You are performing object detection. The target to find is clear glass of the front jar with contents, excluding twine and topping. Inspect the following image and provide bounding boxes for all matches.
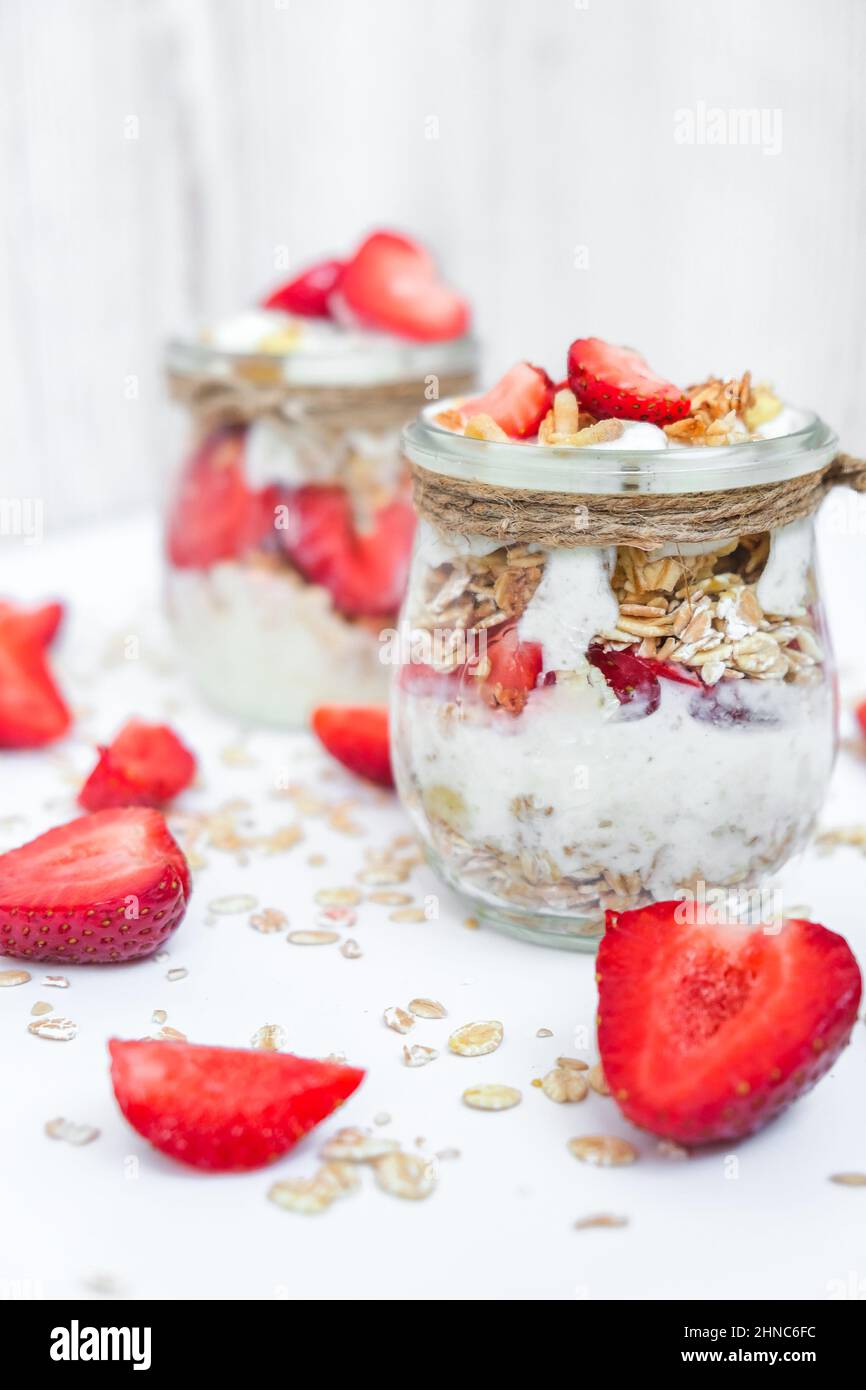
[392,411,837,949]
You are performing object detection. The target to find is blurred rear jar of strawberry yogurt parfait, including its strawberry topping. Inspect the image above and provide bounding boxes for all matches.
[165,232,475,726]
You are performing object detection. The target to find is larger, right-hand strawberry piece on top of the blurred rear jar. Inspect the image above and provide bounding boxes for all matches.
[331,232,468,342]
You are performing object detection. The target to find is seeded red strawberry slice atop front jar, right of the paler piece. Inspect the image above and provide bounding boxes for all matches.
[569,338,689,425]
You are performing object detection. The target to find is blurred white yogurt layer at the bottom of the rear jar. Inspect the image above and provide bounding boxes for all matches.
[168,562,388,727]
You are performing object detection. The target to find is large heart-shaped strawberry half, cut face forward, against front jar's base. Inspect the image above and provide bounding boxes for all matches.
[598,902,862,1144]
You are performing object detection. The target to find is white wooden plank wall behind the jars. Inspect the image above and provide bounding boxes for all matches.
[0,0,866,534]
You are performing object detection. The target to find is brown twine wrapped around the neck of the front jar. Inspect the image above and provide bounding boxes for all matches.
[411,453,866,550]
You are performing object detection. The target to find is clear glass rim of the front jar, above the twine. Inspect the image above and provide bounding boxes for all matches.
[403,400,838,496]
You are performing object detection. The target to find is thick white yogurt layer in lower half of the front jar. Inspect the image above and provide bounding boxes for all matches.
[395,678,834,910]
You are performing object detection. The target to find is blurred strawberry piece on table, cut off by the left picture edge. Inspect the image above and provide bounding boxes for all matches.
[0,602,72,748]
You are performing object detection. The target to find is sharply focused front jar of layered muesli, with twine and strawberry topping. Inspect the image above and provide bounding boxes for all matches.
[392,339,866,948]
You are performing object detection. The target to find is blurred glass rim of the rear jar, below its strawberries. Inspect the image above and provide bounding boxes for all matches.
[165,331,478,386]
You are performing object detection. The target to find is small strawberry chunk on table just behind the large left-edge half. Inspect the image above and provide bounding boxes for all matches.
[78,719,196,810]
